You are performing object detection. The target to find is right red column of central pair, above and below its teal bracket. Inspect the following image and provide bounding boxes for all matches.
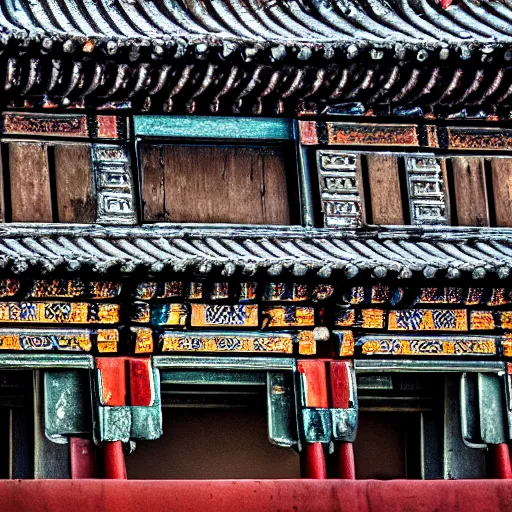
[329,361,356,480]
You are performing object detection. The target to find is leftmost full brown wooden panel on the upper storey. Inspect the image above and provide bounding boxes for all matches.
[9,142,52,222]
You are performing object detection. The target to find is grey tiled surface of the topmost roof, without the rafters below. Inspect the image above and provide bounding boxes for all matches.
[0,0,512,54]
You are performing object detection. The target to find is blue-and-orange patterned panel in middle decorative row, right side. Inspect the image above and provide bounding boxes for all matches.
[388,309,468,331]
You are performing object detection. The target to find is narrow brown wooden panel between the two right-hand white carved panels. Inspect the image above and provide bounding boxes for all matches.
[366,155,404,224]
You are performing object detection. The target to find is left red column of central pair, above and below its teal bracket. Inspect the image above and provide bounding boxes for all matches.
[298,360,329,480]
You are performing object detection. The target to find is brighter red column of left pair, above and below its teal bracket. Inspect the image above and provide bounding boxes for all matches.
[96,357,127,480]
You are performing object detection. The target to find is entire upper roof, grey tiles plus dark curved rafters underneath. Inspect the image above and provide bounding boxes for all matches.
[0,0,512,114]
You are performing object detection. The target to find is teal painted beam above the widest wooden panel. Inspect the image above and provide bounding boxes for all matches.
[133,116,293,140]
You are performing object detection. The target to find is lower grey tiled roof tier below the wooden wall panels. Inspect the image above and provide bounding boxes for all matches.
[0,224,512,279]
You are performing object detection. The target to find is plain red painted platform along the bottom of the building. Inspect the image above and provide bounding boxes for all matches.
[0,480,512,512]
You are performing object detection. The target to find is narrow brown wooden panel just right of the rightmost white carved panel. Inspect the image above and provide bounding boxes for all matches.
[452,157,489,226]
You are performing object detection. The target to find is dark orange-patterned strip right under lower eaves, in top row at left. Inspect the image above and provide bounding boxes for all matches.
[29,279,121,299]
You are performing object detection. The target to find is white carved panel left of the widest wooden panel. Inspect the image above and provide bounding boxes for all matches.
[91,144,137,225]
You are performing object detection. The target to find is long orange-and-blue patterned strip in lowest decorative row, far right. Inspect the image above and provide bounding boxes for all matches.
[356,336,497,356]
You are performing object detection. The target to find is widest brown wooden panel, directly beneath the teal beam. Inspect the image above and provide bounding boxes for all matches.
[141,145,290,224]
